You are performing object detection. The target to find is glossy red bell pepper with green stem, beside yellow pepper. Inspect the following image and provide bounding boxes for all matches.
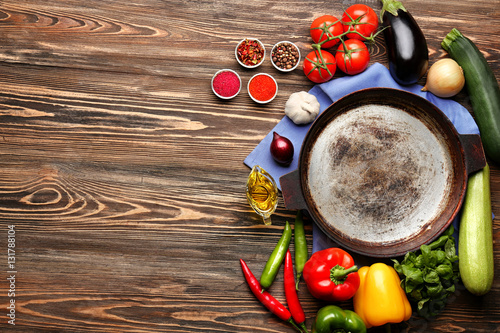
[302,248,360,302]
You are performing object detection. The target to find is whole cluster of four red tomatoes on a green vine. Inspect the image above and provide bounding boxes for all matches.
[303,4,378,83]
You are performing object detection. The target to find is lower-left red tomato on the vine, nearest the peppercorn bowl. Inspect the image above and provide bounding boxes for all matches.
[303,50,337,83]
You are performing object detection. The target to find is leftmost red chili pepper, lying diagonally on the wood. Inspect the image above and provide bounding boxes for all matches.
[240,259,301,332]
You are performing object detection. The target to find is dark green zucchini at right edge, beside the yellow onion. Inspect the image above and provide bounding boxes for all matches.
[441,29,500,164]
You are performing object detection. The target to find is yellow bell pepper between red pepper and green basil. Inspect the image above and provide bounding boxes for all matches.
[353,263,412,328]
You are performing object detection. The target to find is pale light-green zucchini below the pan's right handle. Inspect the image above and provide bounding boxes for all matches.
[458,164,494,296]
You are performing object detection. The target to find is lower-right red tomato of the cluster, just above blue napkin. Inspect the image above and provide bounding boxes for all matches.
[335,39,370,75]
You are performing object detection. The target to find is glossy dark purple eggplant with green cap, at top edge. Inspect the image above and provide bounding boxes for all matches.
[380,0,429,85]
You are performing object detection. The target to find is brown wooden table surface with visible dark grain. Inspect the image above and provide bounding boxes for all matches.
[0,0,500,332]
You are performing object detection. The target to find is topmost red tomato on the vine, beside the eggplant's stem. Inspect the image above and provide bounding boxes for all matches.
[342,4,378,40]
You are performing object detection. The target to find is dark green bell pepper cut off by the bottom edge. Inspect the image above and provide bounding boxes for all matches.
[312,305,366,333]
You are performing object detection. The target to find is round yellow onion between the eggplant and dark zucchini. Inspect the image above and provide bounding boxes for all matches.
[422,58,465,97]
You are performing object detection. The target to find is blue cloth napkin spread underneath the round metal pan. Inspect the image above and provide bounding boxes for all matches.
[244,63,479,253]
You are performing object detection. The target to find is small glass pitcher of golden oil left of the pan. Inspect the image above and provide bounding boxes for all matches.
[247,165,278,225]
